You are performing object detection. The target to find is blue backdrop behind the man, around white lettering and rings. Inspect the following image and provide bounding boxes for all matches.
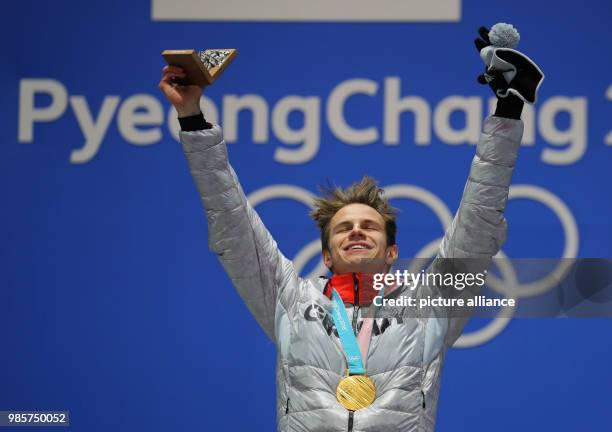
[0,0,612,431]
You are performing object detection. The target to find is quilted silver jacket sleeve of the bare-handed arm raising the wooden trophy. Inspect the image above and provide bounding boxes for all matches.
[180,125,298,340]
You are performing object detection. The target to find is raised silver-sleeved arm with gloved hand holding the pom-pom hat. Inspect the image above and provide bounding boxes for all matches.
[432,24,544,346]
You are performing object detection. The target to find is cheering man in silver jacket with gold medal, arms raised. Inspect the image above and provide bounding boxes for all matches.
[160,29,537,432]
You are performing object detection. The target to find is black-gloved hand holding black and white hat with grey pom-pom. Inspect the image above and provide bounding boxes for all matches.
[474,23,544,104]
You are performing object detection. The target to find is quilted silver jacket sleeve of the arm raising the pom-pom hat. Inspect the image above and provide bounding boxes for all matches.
[434,116,523,346]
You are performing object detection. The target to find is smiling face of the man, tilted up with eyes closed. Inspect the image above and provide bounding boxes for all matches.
[323,203,398,274]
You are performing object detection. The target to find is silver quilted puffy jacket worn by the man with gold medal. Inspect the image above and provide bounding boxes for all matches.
[180,117,523,432]
